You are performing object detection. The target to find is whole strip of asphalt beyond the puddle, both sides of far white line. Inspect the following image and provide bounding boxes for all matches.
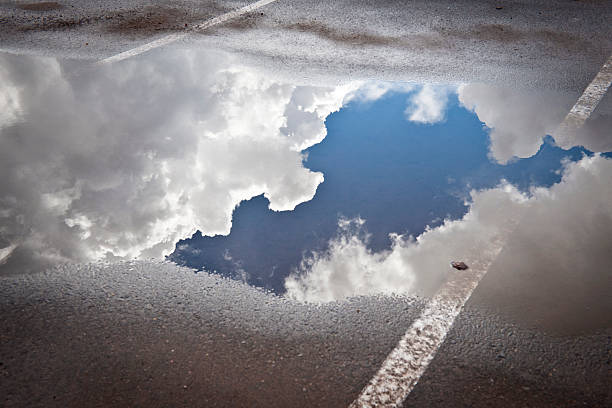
[0,0,612,91]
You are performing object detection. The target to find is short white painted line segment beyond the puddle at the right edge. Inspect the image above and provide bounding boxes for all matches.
[553,55,612,146]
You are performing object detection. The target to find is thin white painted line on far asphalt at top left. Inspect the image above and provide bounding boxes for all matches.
[96,0,277,65]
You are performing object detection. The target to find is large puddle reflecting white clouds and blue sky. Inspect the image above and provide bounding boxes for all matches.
[0,48,612,306]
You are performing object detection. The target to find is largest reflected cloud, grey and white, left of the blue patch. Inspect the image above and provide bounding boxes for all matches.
[0,51,364,272]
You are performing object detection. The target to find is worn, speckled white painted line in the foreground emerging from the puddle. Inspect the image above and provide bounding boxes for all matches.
[350,242,503,408]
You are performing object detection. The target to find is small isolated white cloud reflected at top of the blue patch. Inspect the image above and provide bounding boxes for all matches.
[404,85,448,124]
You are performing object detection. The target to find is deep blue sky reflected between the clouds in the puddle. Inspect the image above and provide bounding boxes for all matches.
[171,90,584,291]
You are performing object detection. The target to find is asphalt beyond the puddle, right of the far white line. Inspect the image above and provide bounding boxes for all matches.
[196,0,612,94]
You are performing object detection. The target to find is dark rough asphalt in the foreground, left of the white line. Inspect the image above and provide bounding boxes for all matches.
[0,262,423,407]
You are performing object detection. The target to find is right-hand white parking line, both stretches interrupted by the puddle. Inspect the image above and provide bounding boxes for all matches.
[350,51,612,408]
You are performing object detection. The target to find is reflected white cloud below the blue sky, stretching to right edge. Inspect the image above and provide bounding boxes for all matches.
[286,156,612,301]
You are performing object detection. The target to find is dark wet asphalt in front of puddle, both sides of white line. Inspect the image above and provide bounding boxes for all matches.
[0,262,612,407]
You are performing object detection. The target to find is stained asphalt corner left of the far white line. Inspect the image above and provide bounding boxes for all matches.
[0,0,248,60]
